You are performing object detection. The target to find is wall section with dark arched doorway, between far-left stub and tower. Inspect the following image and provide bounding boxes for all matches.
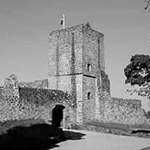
[19,88,74,126]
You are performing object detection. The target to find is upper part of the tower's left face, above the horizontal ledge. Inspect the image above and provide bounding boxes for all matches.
[49,25,83,78]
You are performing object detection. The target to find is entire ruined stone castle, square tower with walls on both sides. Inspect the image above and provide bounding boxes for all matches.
[0,23,150,128]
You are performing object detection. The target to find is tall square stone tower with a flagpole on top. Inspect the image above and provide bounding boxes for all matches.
[49,23,108,124]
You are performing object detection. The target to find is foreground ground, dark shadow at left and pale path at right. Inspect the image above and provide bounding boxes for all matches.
[0,119,150,150]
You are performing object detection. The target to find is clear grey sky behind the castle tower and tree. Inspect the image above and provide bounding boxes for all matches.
[0,0,150,98]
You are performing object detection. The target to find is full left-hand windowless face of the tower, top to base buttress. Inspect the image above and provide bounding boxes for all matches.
[49,24,84,124]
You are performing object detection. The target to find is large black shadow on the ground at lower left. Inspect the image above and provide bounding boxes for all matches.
[0,124,85,150]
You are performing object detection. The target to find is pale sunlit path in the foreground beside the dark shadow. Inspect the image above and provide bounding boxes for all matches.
[53,130,150,150]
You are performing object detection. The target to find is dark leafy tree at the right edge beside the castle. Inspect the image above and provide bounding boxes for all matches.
[124,55,150,98]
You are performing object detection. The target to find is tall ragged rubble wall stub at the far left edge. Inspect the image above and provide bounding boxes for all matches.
[0,74,19,121]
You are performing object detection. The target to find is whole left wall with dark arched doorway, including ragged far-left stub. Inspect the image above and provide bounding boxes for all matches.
[0,76,75,128]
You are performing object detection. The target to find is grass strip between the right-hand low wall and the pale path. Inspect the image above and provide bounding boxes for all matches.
[83,121,150,138]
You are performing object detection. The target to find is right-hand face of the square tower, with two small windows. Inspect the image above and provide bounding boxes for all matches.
[82,24,106,123]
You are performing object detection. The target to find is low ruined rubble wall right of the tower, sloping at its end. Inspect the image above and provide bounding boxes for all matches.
[98,94,150,125]
